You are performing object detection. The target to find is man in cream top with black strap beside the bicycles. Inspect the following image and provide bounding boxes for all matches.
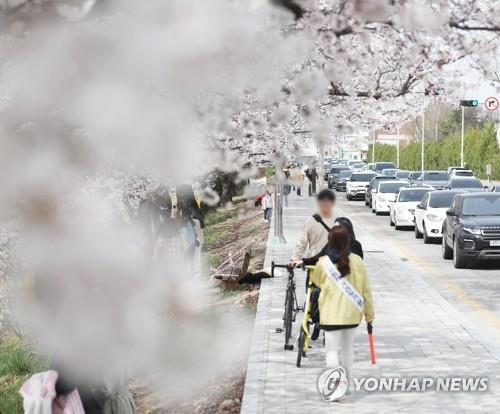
[291,189,335,265]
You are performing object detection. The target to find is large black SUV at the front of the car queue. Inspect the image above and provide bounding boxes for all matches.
[442,193,500,268]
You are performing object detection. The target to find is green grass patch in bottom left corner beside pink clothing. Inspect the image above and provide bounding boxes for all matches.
[0,338,48,414]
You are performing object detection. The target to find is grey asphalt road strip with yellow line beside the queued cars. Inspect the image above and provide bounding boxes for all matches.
[337,192,500,356]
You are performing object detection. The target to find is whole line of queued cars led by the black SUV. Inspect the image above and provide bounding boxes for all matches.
[334,163,500,268]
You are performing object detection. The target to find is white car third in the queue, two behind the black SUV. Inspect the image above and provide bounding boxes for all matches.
[389,187,433,230]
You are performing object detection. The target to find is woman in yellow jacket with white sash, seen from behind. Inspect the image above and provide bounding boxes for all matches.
[311,225,374,381]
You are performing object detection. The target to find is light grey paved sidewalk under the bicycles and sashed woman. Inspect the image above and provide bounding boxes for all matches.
[241,192,500,414]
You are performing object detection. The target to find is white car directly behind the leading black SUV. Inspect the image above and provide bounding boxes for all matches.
[415,190,463,244]
